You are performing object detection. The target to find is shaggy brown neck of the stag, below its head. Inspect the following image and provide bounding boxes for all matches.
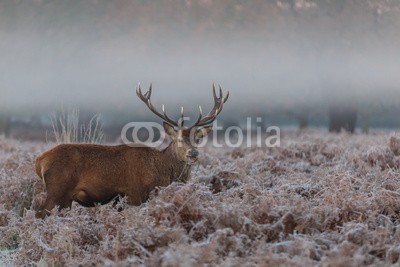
[163,142,191,182]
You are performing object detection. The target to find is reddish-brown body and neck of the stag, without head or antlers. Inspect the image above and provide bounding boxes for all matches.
[35,144,190,217]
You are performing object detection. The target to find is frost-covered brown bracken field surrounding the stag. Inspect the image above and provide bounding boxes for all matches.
[0,130,400,266]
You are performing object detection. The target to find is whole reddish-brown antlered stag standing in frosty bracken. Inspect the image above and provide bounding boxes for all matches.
[35,85,229,218]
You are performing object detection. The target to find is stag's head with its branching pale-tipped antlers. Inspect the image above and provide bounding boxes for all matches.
[136,84,229,164]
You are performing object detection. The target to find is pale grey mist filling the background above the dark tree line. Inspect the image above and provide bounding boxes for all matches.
[0,0,400,127]
